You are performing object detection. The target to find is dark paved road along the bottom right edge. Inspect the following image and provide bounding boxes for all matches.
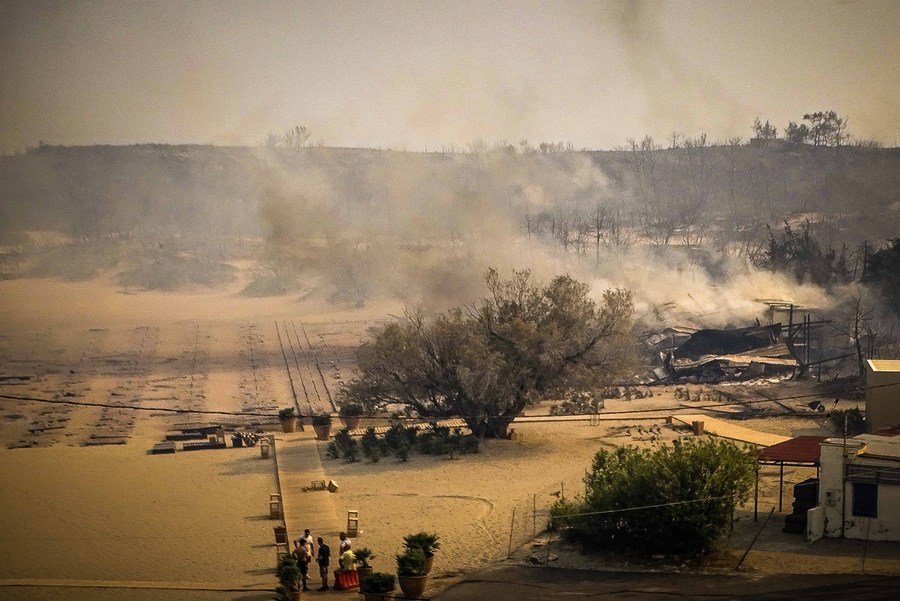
[435,566,900,601]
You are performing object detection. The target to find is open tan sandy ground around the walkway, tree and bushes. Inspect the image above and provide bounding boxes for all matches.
[0,280,900,599]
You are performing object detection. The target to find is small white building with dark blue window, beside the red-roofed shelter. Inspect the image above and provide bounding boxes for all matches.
[810,434,900,541]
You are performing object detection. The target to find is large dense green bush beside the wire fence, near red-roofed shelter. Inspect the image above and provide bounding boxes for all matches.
[551,438,756,555]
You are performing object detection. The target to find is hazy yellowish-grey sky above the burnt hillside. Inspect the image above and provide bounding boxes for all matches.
[0,0,900,152]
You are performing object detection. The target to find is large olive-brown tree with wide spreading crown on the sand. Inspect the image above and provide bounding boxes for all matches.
[341,270,633,437]
